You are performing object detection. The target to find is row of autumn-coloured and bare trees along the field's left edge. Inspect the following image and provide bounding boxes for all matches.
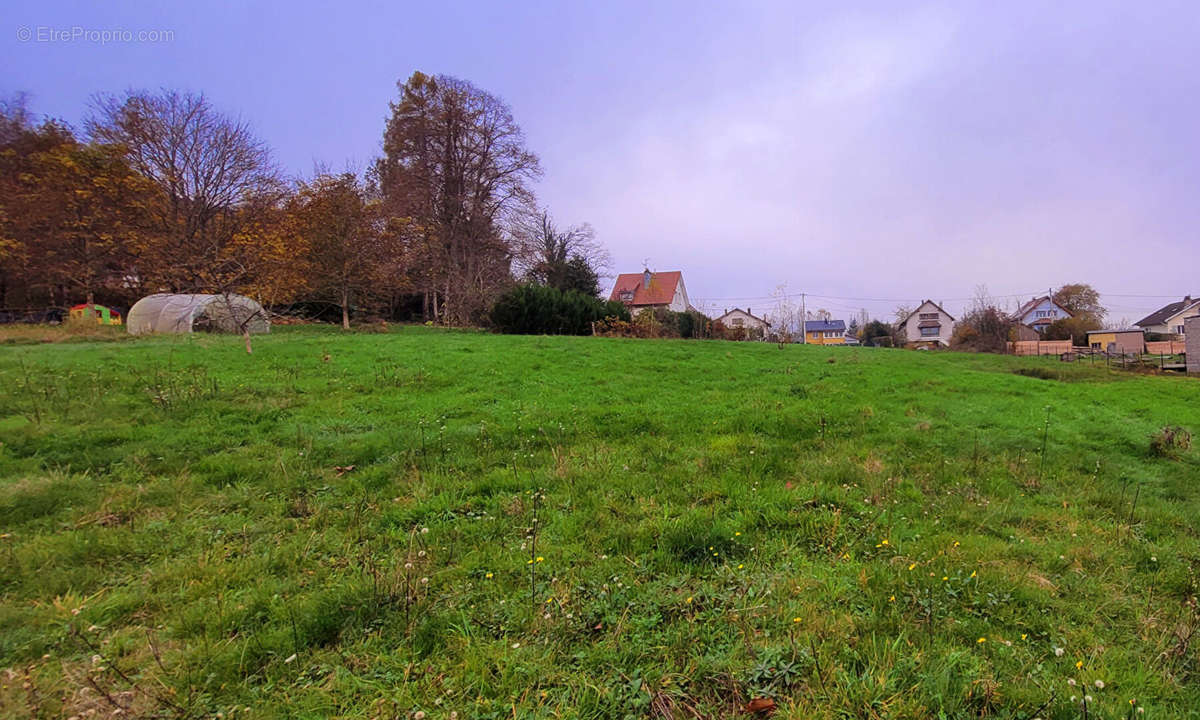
[0,72,608,326]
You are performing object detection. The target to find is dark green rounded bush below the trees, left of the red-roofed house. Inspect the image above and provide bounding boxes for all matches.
[491,284,629,335]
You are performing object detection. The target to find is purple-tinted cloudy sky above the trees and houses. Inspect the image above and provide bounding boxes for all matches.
[0,0,1200,320]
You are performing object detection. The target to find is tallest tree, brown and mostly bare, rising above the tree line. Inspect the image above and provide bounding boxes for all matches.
[374,72,541,324]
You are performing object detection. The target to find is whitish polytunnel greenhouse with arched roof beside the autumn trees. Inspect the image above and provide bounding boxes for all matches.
[125,293,271,335]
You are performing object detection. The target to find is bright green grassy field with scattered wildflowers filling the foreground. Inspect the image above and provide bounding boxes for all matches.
[0,328,1200,720]
